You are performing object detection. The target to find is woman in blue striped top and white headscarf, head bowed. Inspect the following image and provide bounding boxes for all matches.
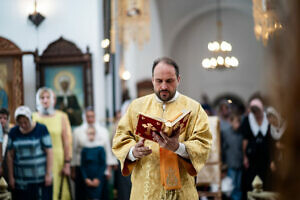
[7,106,53,200]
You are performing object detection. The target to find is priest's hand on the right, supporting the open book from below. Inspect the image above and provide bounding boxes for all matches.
[152,129,180,152]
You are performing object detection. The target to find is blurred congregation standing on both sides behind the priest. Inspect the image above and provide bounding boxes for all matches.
[0,87,286,200]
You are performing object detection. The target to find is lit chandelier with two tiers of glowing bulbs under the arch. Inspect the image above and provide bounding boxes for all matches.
[202,0,239,69]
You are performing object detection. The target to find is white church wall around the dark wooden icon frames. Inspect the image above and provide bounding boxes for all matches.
[0,0,105,121]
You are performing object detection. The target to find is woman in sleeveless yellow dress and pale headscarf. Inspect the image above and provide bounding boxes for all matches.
[32,87,72,200]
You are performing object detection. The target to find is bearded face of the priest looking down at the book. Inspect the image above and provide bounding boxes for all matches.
[152,62,180,101]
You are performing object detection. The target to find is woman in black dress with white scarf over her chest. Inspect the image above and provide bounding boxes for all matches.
[240,98,271,197]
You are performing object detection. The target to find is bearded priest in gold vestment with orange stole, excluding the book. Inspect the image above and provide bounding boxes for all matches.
[113,58,212,200]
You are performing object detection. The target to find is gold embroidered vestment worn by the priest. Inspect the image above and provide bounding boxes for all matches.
[113,94,212,200]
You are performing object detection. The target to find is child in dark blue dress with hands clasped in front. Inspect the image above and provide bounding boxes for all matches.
[80,126,106,200]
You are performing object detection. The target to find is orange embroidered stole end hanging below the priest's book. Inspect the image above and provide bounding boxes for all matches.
[159,147,181,190]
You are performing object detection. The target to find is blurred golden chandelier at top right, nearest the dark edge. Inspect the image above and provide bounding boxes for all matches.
[252,0,282,45]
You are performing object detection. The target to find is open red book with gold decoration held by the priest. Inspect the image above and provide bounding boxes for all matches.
[135,110,191,141]
